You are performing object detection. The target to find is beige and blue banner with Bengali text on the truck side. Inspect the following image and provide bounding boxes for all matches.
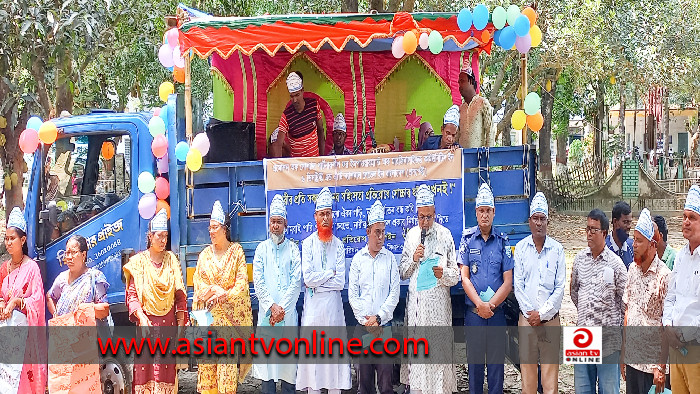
[264,150,464,258]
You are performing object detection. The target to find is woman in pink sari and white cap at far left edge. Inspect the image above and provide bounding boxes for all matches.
[0,207,47,394]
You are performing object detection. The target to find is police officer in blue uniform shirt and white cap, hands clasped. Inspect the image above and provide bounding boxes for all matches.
[457,183,513,394]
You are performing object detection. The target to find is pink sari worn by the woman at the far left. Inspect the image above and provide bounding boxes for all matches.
[0,259,48,394]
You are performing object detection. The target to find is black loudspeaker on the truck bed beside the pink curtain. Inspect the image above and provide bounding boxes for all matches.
[204,118,257,163]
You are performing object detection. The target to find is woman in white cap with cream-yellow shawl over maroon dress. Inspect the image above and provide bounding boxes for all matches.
[124,209,187,394]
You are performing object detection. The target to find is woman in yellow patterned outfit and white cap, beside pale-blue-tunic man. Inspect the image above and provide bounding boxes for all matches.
[192,201,253,394]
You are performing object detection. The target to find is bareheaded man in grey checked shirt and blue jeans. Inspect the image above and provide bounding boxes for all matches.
[571,209,627,394]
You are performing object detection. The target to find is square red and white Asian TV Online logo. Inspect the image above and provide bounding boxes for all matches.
[562,327,603,364]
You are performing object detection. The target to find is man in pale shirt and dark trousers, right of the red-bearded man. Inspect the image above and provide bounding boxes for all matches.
[348,200,400,394]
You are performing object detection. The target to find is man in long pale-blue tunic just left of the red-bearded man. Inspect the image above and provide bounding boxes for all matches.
[253,194,301,394]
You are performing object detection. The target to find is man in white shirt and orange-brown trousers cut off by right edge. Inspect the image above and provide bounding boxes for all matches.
[662,185,700,394]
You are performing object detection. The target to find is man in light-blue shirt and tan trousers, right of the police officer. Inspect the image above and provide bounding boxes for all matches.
[513,192,566,394]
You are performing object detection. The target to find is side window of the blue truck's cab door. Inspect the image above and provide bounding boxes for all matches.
[44,133,131,241]
